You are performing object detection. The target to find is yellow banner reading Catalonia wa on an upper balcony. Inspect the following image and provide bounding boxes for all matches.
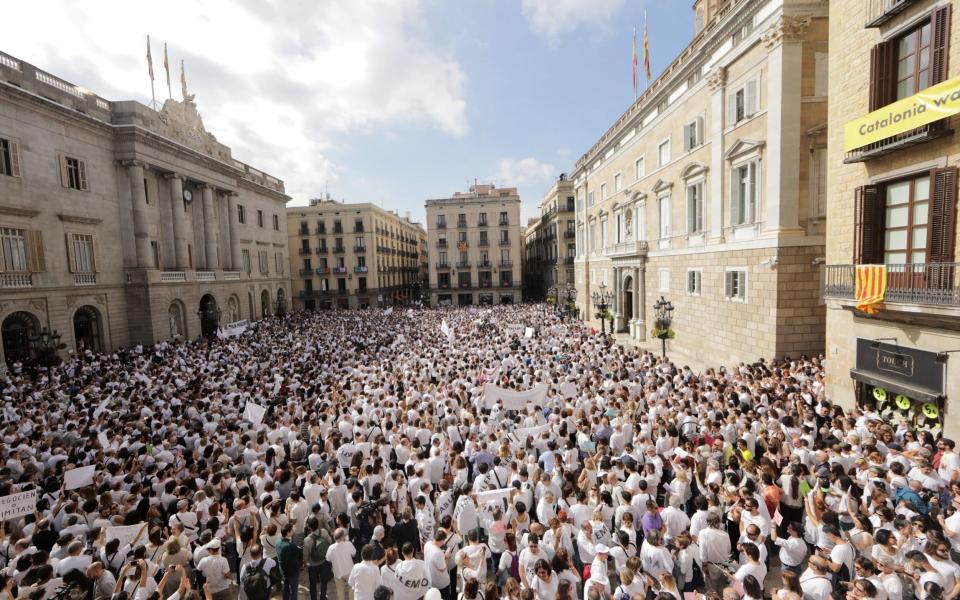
[843,77,960,152]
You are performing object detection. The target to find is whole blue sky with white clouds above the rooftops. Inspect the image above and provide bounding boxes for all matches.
[0,0,693,219]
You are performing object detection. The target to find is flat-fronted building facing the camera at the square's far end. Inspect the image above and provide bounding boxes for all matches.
[425,184,522,306]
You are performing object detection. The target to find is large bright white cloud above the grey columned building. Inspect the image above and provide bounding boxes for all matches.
[0,0,468,199]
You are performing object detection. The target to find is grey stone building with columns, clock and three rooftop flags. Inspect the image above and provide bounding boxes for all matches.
[0,53,290,369]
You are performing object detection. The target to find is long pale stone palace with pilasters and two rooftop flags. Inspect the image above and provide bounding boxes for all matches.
[571,0,828,366]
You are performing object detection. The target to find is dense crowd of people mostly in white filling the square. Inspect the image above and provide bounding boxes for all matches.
[0,306,960,600]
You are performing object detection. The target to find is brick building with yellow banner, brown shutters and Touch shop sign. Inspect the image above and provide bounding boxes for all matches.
[824,0,960,437]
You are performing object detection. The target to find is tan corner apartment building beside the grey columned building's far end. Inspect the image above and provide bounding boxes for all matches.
[287,196,427,310]
